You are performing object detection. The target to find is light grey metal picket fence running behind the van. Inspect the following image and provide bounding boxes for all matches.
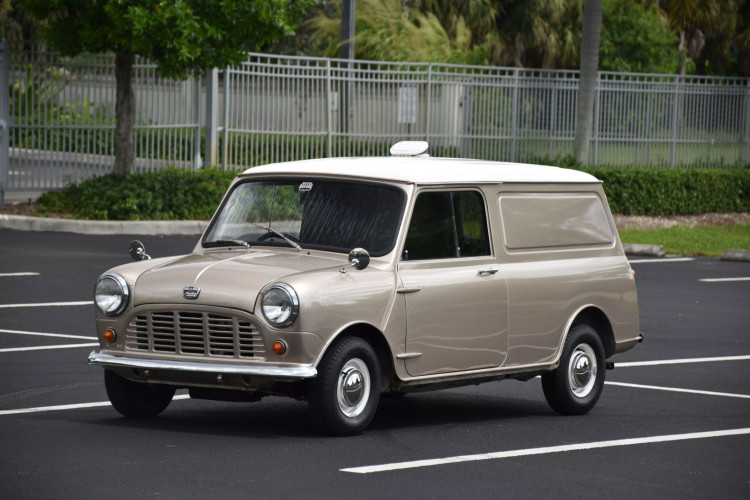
[0,42,750,198]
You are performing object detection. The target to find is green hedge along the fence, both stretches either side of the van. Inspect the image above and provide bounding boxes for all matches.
[38,167,750,220]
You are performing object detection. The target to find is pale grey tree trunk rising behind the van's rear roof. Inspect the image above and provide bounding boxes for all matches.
[574,0,602,165]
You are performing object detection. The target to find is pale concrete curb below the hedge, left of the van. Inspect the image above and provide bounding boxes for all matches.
[0,214,208,236]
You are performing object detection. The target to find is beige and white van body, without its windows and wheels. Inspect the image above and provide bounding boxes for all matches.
[90,146,642,432]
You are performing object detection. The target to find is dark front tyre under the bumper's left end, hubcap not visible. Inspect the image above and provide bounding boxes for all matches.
[104,370,175,418]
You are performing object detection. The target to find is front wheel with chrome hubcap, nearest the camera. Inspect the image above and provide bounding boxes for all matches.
[308,337,380,436]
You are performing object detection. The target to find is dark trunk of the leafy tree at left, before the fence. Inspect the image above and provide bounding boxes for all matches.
[112,53,135,175]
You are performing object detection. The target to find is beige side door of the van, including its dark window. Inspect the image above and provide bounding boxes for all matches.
[398,190,508,376]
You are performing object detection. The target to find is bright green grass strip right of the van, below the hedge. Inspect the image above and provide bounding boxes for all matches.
[619,225,750,257]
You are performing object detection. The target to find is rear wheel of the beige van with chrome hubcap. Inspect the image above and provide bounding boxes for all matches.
[542,324,605,415]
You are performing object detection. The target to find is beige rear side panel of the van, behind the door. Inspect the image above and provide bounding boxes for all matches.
[495,184,639,368]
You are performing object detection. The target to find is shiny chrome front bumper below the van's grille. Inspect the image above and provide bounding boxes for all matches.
[89,351,318,380]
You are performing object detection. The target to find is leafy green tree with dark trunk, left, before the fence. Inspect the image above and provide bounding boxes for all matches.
[22,0,311,174]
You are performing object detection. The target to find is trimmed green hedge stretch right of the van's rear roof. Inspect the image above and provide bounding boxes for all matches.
[579,167,750,215]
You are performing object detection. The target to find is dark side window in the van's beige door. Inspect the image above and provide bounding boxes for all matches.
[402,191,490,260]
